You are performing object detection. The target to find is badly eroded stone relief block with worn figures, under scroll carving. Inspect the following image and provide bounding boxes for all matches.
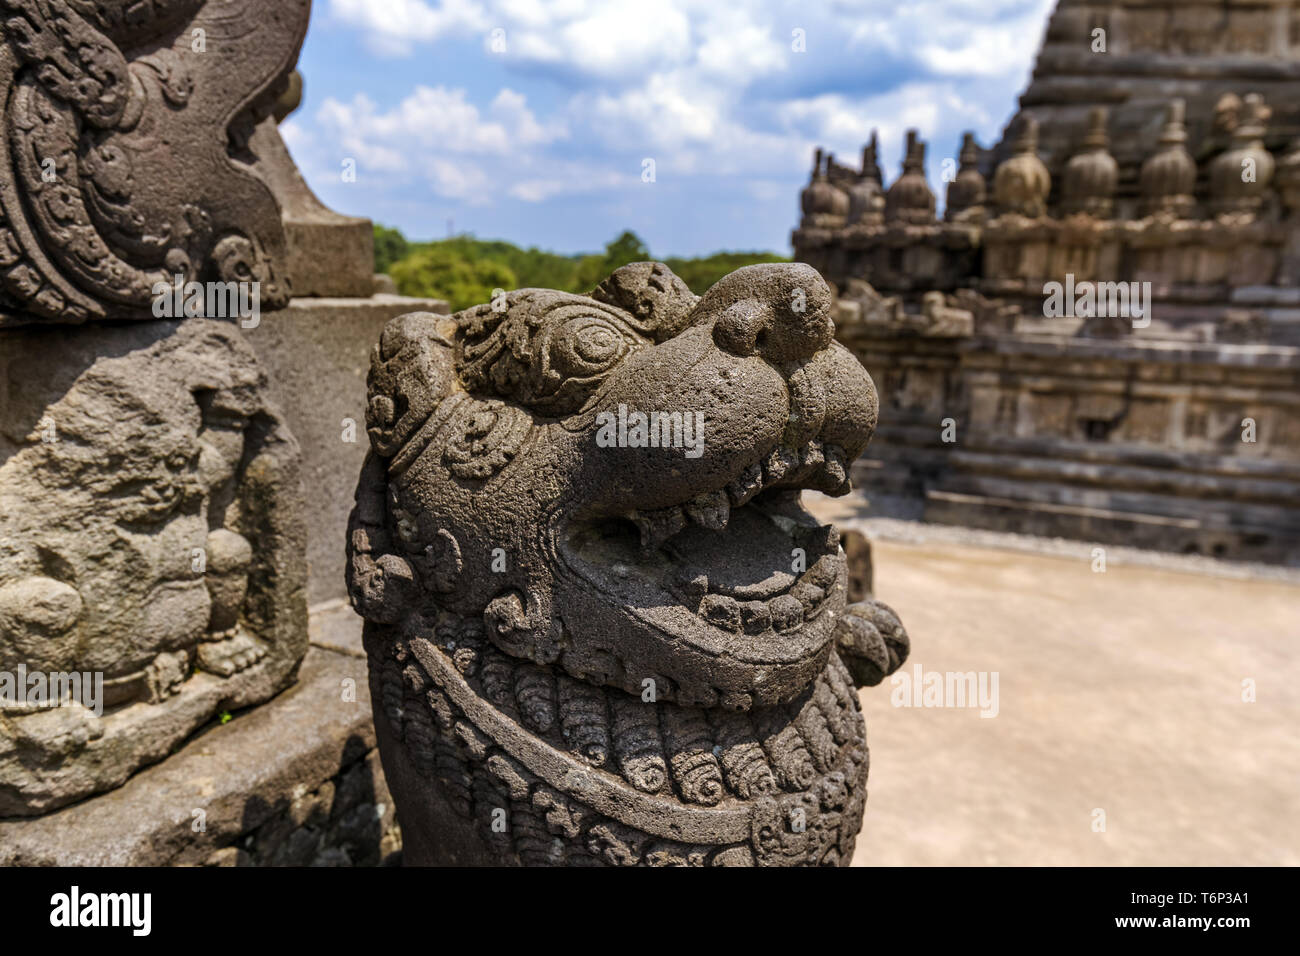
[0,319,307,816]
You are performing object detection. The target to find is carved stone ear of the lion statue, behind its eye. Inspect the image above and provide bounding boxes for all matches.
[365,312,456,458]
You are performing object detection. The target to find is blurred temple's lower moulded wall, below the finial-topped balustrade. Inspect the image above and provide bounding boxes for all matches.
[850,338,1300,564]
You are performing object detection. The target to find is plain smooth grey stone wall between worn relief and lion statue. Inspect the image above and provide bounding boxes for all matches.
[244,295,449,606]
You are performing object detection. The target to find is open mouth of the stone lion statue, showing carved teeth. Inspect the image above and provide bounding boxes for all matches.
[559,441,845,701]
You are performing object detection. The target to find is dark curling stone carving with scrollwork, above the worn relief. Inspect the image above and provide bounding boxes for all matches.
[0,0,311,324]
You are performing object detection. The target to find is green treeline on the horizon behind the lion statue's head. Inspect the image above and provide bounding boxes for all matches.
[374,225,789,311]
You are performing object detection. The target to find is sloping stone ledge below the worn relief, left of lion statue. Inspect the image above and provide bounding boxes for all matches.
[0,607,400,866]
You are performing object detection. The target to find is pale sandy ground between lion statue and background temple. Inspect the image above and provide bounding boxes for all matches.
[809,496,1300,866]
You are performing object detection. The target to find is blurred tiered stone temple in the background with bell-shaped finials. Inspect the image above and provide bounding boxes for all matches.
[793,0,1300,563]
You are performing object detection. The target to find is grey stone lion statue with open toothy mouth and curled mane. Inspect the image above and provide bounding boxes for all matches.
[348,263,907,866]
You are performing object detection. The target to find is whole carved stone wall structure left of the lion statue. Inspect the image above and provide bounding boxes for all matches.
[0,0,436,865]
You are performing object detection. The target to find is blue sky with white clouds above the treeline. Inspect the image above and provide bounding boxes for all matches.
[283,0,1053,256]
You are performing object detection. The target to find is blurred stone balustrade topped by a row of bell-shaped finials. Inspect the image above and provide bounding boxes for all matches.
[792,92,1300,323]
